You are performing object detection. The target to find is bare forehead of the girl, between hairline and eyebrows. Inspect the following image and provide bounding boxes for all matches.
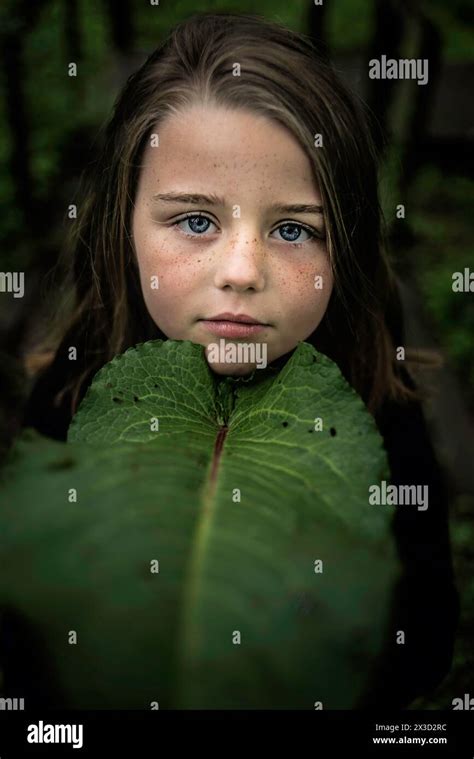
[138,105,317,197]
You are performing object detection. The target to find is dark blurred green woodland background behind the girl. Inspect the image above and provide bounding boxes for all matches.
[0,0,474,709]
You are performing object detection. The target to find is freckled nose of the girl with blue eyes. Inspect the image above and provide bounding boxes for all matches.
[215,231,265,292]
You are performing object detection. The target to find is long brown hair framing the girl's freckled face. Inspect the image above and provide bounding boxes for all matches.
[25,13,434,413]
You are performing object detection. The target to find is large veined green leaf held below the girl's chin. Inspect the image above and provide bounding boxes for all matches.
[0,340,400,709]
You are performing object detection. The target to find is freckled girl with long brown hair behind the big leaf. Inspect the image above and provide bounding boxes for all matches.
[20,14,457,705]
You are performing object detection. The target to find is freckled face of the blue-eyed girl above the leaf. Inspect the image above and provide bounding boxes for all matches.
[132,105,333,375]
